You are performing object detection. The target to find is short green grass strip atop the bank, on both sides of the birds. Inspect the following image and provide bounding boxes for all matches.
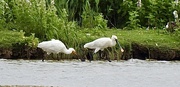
[0,29,180,49]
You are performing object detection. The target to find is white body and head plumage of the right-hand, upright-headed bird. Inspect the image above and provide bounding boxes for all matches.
[84,35,117,53]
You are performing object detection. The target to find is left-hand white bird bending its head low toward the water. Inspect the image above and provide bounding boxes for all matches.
[37,39,77,61]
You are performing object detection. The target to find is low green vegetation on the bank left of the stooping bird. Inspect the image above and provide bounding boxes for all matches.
[0,30,39,48]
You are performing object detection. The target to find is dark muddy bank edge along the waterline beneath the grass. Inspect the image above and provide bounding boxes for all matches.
[0,43,180,61]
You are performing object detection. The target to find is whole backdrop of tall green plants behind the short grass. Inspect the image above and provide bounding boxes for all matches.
[0,0,180,30]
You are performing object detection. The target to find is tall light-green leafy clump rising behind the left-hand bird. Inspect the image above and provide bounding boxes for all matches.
[0,0,77,40]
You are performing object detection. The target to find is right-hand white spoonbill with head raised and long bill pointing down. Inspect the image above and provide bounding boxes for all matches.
[84,35,124,62]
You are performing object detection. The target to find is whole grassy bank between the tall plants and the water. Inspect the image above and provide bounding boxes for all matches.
[0,29,180,60]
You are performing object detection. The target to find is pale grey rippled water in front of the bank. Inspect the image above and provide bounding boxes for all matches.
[0,59,180,87]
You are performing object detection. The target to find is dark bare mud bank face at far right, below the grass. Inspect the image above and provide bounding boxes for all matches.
[132,43,180,60]
